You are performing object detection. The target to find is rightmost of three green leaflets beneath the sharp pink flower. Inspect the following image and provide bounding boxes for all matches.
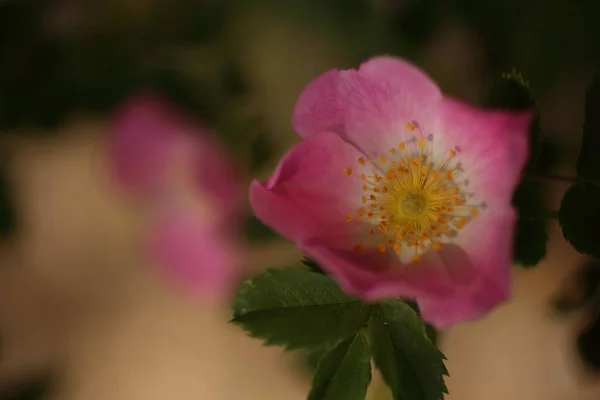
[369,300,448,400]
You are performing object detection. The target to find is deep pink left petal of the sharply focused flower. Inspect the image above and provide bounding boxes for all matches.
[250,132,363,242]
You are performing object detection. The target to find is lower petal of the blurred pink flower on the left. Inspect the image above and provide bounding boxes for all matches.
[149,209,239,300]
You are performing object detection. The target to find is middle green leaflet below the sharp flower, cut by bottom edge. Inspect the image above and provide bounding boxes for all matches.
[308,332,371,400]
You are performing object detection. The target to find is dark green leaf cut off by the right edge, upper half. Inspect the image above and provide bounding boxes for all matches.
[577,75,600,180]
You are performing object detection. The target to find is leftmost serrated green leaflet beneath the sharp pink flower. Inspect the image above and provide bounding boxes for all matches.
[233,268,371,349]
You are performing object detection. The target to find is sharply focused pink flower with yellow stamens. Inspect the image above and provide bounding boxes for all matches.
[250,57,532,328]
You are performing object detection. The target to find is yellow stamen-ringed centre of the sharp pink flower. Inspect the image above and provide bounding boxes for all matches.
[346,122,485,261]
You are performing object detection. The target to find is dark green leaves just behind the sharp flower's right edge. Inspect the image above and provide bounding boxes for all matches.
[487,70,548,267]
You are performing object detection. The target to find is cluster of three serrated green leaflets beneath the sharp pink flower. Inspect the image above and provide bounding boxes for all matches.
[233,259,448,400]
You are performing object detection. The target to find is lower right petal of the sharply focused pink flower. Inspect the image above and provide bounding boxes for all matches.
[419,208,516,329]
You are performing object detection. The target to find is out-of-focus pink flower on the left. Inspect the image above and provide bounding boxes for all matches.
[109,94,241,298]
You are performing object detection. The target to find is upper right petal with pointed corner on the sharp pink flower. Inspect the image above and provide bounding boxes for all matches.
[435,98,533,206]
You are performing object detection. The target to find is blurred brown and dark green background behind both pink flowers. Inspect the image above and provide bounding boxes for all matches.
[0,0,600,400]
